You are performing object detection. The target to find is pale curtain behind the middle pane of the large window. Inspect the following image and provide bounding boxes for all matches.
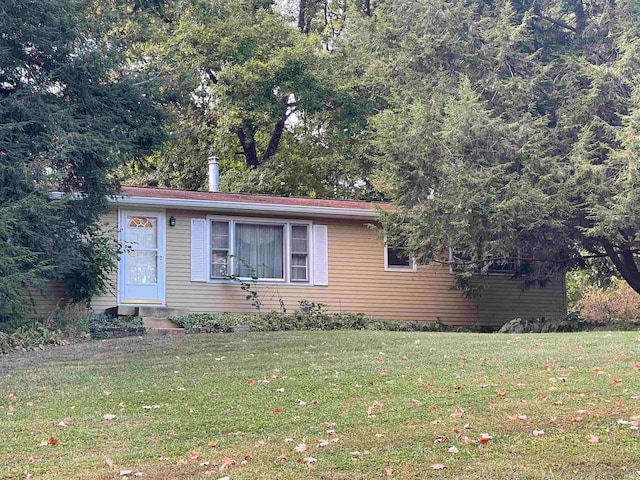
[235,223,284,278]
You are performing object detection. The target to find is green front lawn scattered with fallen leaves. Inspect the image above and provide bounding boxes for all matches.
[0,331,640,480]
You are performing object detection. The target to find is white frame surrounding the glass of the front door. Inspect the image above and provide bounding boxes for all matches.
[117,208,167,306]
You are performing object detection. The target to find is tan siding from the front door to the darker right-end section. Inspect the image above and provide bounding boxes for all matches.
[160,211,476,324]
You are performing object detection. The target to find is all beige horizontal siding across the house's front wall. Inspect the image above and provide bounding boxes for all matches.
[87,209,565,325]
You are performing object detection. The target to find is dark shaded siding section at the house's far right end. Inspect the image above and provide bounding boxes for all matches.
[476,276,567,326]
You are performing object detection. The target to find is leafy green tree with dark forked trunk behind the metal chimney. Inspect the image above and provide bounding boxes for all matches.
[121,0,380,197]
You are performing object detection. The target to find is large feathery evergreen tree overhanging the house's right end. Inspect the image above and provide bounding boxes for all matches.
[372,0,640,292]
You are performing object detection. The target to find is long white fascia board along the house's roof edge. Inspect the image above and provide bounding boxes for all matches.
[109,195,378,218]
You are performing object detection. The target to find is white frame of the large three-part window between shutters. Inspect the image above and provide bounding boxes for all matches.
[205,215,314,286]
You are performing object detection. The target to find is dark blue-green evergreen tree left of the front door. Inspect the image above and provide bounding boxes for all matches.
[0,0,162,323]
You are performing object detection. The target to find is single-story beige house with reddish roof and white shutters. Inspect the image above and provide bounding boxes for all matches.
[34,163,566,326]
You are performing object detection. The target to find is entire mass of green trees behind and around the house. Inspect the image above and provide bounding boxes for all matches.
[0,0,640,315]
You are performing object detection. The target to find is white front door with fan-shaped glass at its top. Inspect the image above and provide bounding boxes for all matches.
[118,211,165,305]
